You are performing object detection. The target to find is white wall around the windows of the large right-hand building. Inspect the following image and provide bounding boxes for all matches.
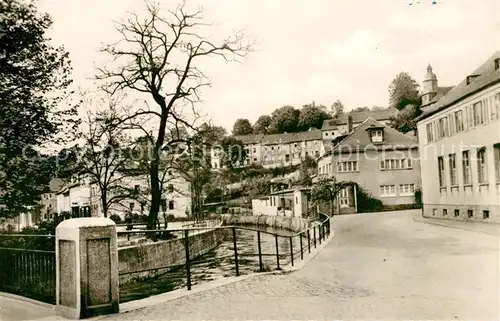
[418,84,500,221]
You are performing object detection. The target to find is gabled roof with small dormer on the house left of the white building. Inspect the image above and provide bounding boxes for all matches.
[332,118,417,153]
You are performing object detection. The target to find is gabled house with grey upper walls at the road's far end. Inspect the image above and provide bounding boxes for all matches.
[318,118,420,213]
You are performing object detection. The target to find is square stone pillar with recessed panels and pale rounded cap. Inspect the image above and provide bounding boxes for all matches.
[56,217,119,319]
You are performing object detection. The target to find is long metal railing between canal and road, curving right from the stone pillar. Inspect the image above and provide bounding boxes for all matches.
[118,214,331,302]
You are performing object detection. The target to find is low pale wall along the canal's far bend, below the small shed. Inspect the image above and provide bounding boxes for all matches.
[222,215,312,232]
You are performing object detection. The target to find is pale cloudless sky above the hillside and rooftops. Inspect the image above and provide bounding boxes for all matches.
[38,0,500,131]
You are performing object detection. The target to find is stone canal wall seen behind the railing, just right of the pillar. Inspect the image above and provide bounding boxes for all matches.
[118,229,228,284]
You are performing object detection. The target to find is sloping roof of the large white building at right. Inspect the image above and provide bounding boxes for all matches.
[417,51,500,121]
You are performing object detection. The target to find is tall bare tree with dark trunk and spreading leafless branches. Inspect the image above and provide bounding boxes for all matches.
[97,1,251,228]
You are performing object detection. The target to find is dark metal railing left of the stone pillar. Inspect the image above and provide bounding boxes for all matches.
[0,234,56,304]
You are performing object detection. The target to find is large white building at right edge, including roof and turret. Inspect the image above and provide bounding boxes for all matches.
[418,51,500,222]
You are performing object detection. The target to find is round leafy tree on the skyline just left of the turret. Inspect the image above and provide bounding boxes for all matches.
[389,72,420,110]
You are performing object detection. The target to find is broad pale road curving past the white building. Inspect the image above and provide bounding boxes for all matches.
[103,212,500,321]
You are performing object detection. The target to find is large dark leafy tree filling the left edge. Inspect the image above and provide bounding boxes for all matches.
[0,0,78,217]
